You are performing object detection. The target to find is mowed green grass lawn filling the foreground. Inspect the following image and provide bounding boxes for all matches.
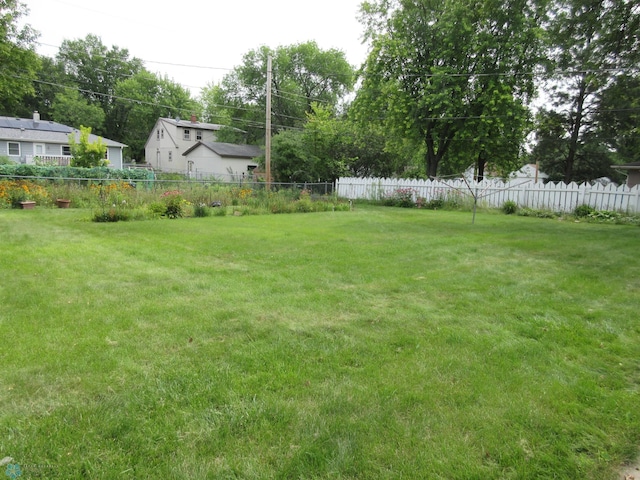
[0,207,640,479]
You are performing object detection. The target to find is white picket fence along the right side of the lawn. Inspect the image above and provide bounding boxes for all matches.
[336,177,640,214]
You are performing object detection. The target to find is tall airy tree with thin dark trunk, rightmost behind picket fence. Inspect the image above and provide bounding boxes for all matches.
[538,0,640,182]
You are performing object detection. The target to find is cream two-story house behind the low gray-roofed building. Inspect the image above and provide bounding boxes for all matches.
[144,115,230,173]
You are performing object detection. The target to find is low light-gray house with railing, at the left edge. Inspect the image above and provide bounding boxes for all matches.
[0,112,126,168]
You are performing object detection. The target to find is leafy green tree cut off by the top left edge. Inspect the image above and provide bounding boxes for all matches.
[0,0,39,115]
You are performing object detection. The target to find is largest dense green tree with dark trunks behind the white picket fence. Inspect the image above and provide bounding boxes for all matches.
[355,0,541,177]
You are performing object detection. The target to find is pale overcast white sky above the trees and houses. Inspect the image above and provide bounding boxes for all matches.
[22,0,367,97]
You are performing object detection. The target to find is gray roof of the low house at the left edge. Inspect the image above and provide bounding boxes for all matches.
[0,117,126,147]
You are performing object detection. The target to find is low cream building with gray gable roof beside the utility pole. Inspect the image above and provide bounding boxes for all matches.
[182,142,263,180]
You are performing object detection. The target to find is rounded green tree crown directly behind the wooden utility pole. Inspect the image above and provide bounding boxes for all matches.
[202,42,354,143]
